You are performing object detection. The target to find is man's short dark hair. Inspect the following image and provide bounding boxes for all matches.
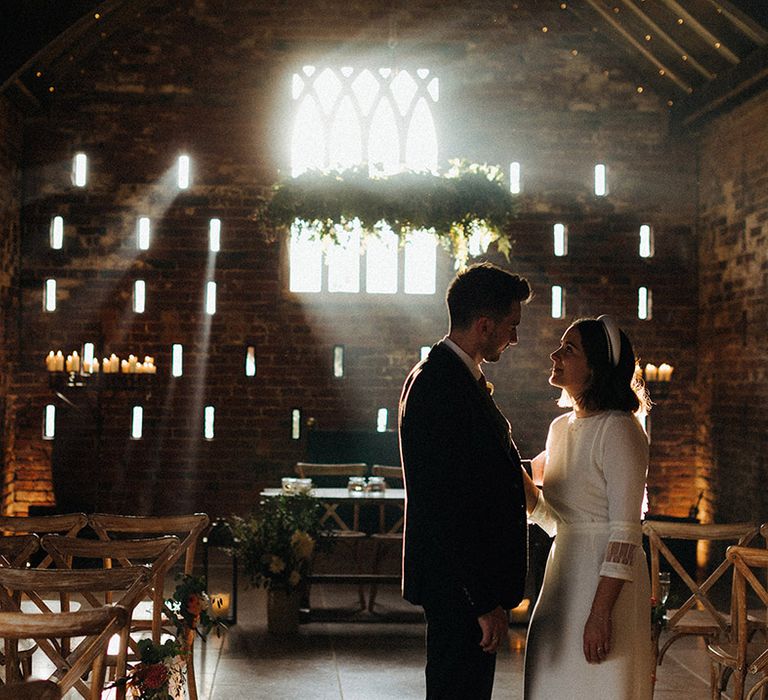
[445,262,531,329]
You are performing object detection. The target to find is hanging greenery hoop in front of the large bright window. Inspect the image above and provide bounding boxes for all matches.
[257,160,516,268]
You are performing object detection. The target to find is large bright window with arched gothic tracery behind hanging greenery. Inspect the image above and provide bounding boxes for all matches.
[290,66,439,294]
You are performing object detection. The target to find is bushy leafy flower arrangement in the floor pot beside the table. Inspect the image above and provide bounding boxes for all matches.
[232,494,330,592]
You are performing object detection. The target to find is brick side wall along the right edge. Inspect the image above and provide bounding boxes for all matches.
[696,93,768,521]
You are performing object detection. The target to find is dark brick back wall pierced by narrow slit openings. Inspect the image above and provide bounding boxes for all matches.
[6,0,697,515]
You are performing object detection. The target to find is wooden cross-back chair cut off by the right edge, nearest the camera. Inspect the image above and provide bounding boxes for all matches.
[707,546,768,700]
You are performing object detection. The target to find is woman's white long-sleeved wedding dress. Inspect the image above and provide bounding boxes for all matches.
[524,411,655,700]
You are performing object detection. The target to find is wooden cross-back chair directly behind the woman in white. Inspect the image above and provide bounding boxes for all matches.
[643,520,759,665]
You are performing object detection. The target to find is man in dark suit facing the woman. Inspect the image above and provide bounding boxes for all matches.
[400,263,531,700]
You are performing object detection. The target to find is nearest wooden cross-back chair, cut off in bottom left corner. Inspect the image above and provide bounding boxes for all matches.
[0,605,129,700]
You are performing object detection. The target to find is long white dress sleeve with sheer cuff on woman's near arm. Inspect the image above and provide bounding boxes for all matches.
[600,415,648,581]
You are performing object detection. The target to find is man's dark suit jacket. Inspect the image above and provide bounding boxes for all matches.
[399,343,527,615]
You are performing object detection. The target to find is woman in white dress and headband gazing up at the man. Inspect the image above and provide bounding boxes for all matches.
[524,316,654,700]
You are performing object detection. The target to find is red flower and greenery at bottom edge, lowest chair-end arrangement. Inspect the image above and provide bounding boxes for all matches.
[121,639,184,700]
